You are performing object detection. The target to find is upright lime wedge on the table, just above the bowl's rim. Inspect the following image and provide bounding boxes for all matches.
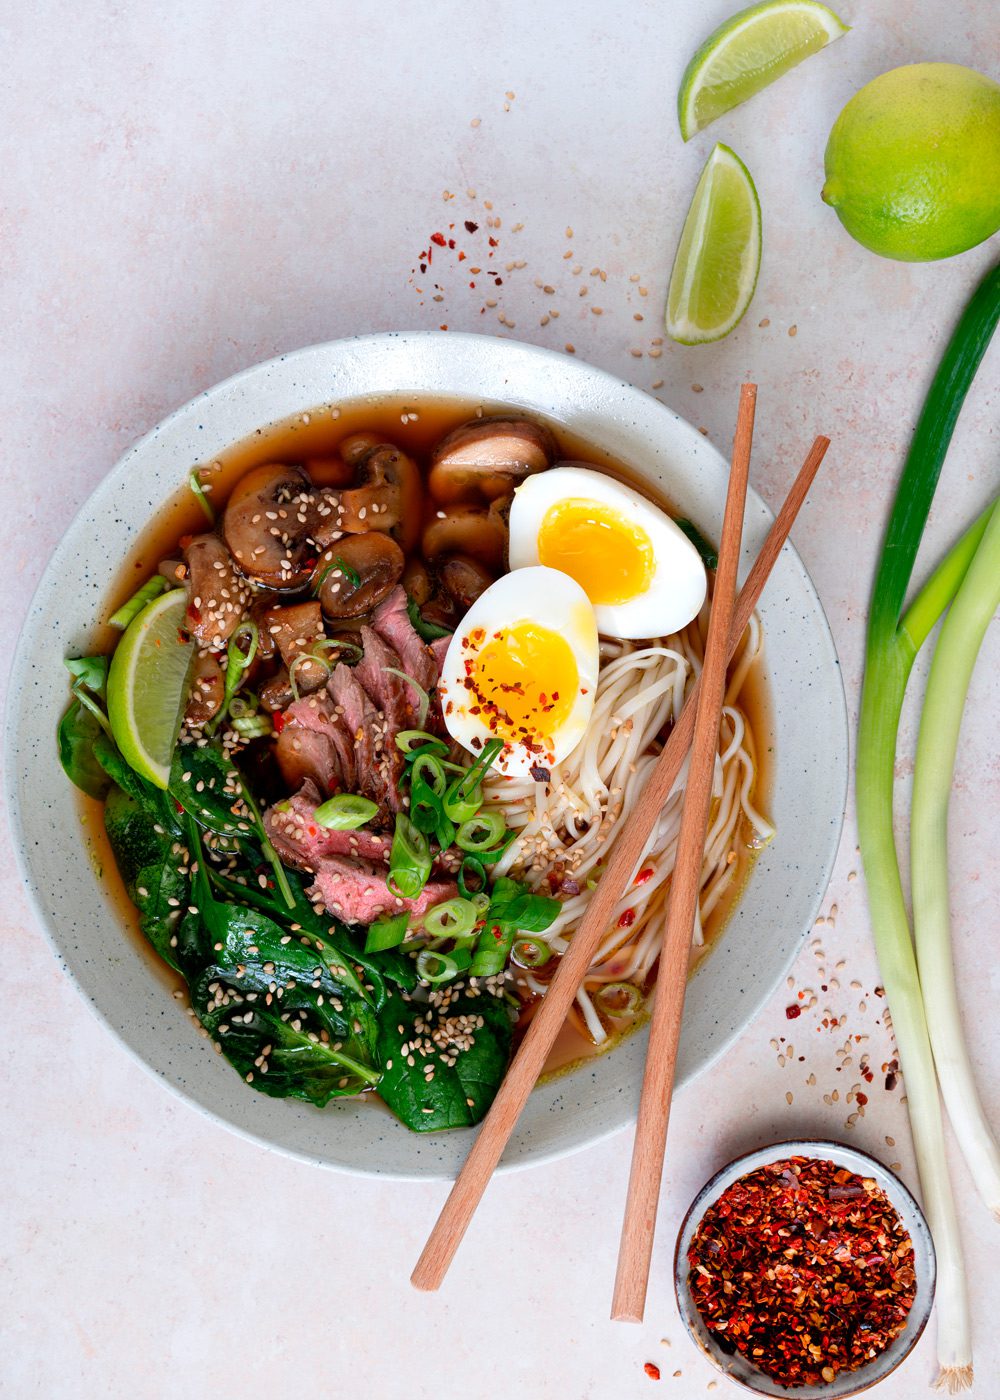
[667,146,761,346]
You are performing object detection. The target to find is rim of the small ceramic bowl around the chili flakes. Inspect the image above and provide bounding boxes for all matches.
[674,1138,937,1400]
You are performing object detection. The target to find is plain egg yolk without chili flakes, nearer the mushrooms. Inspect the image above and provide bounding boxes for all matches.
[538,498,655,606]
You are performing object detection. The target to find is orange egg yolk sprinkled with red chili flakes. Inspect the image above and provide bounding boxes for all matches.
[466,622,580,748]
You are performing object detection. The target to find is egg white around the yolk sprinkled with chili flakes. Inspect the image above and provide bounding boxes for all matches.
[438,564,599,776]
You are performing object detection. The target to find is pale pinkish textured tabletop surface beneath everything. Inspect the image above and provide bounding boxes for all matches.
[0,0,1000,1400]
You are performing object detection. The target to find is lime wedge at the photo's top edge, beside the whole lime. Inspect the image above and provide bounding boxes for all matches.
[676,0,850,141]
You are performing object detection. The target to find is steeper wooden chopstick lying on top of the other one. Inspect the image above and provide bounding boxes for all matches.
[611,384,756,1322]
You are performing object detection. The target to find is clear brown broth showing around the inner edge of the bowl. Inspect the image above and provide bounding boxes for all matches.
[78,395,773,1078]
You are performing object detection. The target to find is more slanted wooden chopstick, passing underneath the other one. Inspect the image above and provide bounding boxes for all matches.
[410,417,829,1291]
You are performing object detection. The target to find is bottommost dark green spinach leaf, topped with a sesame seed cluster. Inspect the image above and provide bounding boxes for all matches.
[378,991,513,1133]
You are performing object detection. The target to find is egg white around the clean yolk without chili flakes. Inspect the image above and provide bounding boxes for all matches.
[510,466,707,637]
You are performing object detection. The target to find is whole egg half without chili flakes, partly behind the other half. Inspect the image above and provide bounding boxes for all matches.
[507,466,706,637]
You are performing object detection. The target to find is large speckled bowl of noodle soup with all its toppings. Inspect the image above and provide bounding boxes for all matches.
[7,333,847,1177]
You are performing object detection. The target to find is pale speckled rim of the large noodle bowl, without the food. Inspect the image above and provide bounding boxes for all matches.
[7,333,847,1179]
